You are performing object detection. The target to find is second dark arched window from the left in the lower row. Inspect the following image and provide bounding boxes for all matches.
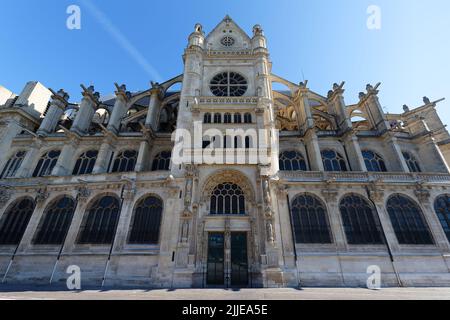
[33,197,75,245]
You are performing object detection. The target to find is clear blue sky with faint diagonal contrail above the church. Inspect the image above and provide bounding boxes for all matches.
[0,0,450,123]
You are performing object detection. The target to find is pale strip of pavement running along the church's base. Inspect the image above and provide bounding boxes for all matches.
[0,285,450,300]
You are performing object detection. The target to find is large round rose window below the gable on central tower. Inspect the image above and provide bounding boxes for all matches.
[210,72,247,97]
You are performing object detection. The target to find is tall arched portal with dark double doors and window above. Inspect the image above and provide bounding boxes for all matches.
[199,170,256,288]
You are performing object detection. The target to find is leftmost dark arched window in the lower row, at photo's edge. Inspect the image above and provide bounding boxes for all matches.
[0,199,34,245]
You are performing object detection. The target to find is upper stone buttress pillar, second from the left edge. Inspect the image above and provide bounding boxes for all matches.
[70,85,100,135]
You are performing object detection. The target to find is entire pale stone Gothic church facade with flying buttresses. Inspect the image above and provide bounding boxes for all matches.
[0,16,450,288]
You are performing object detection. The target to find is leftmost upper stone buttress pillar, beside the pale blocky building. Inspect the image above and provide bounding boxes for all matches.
[37,89,69,135]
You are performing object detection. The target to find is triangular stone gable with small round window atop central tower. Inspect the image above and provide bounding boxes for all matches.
[205,15,251,51]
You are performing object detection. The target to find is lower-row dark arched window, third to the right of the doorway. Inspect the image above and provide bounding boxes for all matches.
[386,195,433,244]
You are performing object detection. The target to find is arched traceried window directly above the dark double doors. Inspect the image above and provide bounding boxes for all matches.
[210,182,245,215]
